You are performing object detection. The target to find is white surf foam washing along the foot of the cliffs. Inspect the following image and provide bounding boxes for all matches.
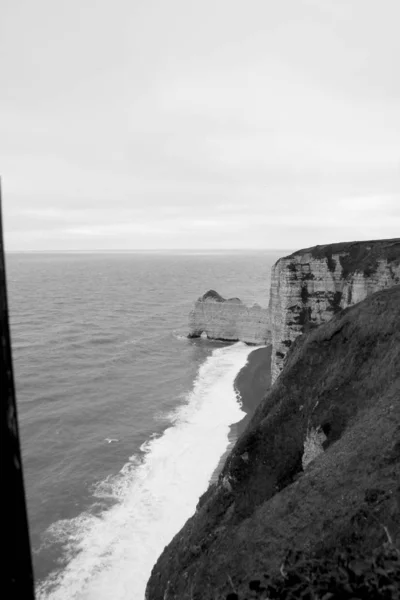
[37,342,252,600]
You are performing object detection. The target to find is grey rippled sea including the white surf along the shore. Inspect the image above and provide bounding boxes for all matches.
[7,251,283,600]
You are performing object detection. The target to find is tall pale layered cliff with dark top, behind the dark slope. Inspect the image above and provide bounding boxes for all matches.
[269,239,400,381]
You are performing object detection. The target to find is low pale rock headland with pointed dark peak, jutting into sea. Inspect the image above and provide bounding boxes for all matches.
[189,290,271,344]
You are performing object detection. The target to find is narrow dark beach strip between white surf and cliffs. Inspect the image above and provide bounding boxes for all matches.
[209,345,272,485]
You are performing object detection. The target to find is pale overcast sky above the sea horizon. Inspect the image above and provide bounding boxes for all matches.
[0,0,400,251]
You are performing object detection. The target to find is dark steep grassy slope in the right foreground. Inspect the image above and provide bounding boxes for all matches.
[146,288,400,600]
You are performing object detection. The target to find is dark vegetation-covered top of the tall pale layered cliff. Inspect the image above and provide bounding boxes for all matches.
[285,238,400,277]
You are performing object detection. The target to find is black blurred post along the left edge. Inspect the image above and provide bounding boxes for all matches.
[0,183,34,600]
